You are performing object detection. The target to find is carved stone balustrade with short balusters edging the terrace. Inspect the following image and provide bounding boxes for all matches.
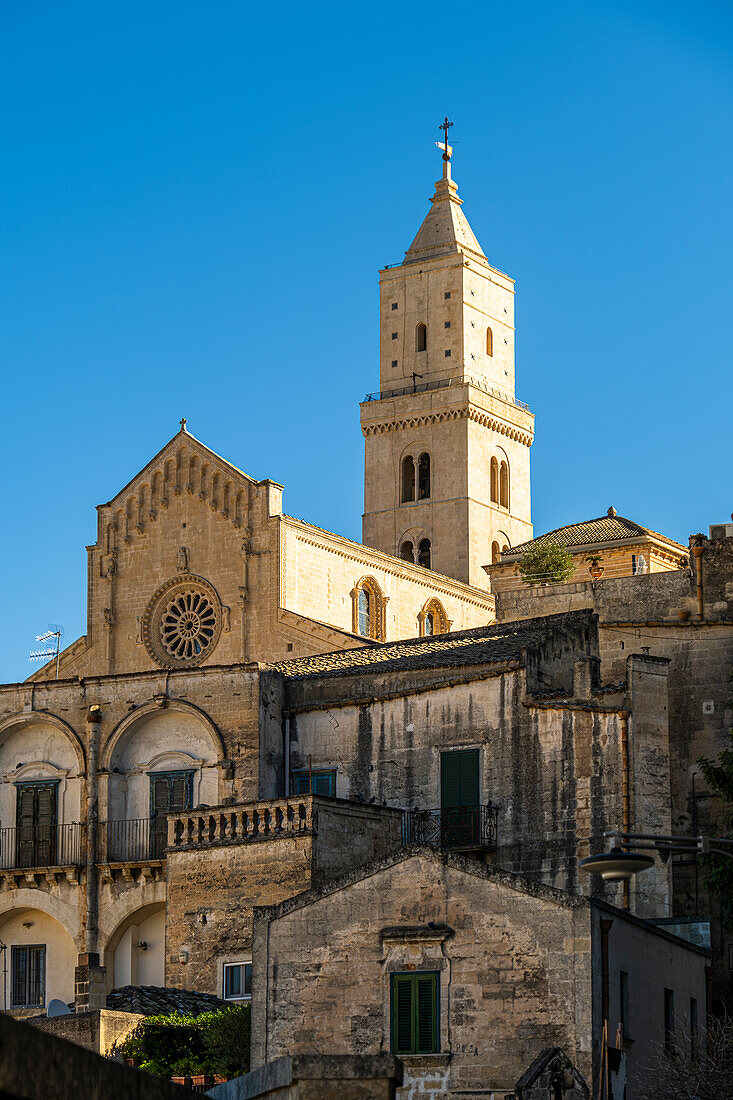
[168,795,313,850]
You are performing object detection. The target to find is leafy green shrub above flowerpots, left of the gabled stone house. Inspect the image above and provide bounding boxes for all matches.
[110,1004,250,1077]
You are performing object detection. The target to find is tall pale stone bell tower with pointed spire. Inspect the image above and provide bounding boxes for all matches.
[361,125,534,589]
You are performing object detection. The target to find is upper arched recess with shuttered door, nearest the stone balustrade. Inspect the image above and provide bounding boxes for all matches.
[100,700,225,836]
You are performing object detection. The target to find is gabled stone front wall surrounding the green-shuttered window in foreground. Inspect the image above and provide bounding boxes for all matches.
[252,850,591,1098]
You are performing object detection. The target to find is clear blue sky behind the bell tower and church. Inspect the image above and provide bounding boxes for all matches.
[0,0,733,681]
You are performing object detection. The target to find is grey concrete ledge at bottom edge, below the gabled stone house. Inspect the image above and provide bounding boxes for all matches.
[207,1054,403,1100]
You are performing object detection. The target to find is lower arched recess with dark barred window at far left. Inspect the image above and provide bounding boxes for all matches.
[0,889,83,1009]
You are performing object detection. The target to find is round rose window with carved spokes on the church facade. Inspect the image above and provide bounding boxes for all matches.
[142,573,221,669]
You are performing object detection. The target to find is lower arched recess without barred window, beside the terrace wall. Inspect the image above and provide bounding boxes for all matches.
[102,901,165,990]
